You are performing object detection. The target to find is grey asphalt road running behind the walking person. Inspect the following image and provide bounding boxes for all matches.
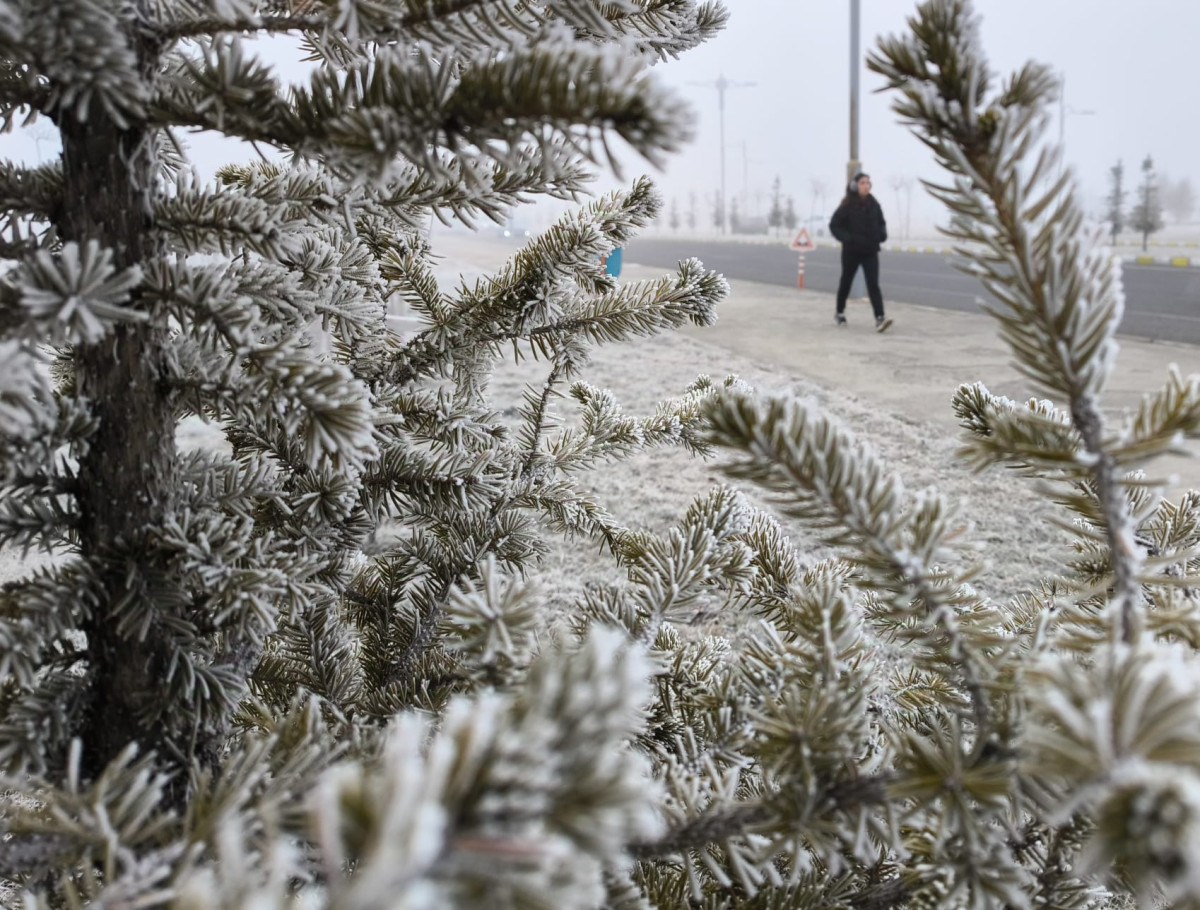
[624,239,1200,345]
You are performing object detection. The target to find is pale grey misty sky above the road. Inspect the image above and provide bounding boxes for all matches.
[0,0,1200,240]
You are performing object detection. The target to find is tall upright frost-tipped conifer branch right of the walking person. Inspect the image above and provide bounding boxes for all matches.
[869,2,1200,642]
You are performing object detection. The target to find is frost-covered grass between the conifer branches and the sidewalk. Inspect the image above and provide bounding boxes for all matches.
[0,253,1080,622]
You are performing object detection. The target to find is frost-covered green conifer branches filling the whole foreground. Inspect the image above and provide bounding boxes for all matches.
[0,0,1200,910]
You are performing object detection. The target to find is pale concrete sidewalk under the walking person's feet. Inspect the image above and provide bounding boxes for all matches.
[620,263,1200,497]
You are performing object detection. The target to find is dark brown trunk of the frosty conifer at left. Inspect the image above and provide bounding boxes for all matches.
[60,104,175,777]
